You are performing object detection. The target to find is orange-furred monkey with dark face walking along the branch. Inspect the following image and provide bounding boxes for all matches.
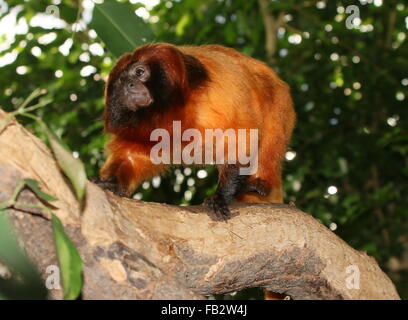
[100,43,296,221]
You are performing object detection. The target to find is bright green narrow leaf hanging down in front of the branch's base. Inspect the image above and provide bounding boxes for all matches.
[52,214,82,300]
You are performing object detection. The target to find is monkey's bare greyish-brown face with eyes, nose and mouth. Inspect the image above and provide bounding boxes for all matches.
[110,62,153,111]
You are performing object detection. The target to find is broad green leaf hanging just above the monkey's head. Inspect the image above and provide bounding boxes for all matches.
[91,1,154,57]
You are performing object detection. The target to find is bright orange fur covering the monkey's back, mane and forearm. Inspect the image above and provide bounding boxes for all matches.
[101,43,295,202]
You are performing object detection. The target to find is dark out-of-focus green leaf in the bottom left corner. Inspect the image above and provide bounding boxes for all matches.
[0,210,48,299]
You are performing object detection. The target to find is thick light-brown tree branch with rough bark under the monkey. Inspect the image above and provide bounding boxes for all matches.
[0,110,399,299]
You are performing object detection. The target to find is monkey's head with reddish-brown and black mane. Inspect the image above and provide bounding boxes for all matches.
[105,43,207,130]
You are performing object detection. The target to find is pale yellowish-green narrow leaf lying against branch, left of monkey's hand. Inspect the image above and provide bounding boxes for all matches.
[47,129,86,205]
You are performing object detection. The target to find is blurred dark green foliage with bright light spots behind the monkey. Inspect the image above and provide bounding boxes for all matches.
[0,0,408,299]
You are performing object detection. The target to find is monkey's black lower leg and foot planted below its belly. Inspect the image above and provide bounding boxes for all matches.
[204,164,248,221]
